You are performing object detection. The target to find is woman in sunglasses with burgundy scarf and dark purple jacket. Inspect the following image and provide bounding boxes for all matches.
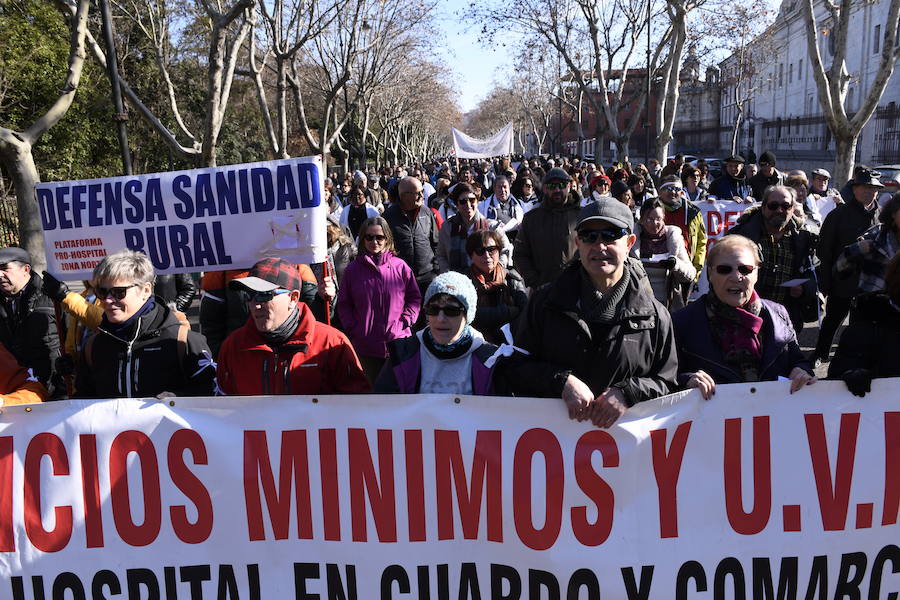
[672,235,816,400]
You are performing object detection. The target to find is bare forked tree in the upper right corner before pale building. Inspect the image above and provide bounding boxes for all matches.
[803,0,900,185]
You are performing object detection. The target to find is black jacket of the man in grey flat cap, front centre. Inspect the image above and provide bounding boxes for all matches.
[506,258,678,406]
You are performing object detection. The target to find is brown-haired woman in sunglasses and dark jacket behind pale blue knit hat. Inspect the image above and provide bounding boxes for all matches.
[466,229,528,344]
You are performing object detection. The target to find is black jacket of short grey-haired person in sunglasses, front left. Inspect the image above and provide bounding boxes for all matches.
[76,298,216,398]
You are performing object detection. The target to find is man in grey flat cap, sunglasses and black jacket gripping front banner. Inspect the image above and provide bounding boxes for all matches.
[509,200,678,428]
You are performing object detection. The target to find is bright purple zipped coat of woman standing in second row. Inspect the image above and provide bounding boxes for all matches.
[337,254,422,358]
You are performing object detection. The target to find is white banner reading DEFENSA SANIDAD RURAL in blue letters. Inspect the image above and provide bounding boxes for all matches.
[37,156,327,280]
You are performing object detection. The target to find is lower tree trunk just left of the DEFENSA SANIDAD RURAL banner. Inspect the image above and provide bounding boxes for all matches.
[0,136,47,271]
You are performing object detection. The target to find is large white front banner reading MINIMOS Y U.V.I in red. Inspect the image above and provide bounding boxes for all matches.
[0,379,900,600]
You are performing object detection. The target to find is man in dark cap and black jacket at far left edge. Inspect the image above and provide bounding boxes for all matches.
[0,247,63,396]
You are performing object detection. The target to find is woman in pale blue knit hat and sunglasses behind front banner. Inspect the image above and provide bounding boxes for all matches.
[375,271,506,396]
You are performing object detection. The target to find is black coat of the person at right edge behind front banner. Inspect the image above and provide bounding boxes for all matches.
[828,292,900,379]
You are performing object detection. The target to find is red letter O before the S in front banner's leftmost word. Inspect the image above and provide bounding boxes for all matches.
[109,431,162,546]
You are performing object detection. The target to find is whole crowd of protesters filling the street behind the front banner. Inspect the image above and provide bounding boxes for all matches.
[0,152,900,427]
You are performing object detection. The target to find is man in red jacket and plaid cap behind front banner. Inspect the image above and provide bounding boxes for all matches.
[217,258,370,396]
